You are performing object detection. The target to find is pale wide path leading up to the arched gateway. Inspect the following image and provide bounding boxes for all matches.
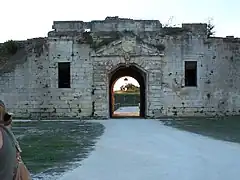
[58,119,240,180]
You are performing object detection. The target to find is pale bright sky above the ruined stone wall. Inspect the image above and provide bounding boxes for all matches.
[0,0,240,42]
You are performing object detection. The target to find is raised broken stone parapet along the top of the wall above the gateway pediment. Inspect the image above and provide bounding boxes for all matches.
[48,16,211,36]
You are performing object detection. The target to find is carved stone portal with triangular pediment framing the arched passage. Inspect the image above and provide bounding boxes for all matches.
[91,35,165,118]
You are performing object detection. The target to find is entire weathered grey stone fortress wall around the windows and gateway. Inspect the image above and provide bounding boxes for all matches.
[0,17,240,119]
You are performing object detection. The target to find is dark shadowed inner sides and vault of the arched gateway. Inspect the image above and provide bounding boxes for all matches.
[109,64,146,118]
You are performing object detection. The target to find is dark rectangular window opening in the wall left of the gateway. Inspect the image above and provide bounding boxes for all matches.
[58,62,71,88]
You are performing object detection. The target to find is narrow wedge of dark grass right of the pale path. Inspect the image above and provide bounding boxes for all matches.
[160,116,240,143]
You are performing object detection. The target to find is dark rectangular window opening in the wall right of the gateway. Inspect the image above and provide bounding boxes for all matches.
[185,61,197,87]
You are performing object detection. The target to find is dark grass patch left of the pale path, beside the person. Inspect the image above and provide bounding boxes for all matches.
[13,121,104,179]
